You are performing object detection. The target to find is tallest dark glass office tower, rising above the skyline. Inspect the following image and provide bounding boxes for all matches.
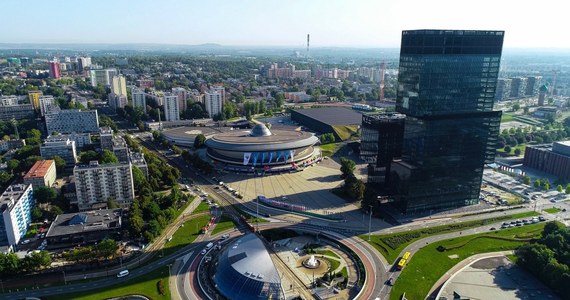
[390,30,504,212]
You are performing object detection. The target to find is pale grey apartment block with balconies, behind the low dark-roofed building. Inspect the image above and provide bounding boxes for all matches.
[73,161,135,211]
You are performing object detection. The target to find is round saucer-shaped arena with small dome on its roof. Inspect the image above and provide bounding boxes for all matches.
[206,124,321,172]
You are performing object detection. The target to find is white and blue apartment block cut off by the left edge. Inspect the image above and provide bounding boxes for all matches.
[0,184,35,247]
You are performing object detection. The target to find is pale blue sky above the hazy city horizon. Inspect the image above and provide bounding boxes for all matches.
[0,0,570,48]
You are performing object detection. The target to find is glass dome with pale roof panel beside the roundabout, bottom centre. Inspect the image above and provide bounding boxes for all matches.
[214,233,285,300]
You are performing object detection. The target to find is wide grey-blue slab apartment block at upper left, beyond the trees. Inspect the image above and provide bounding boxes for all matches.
[45,109,99,134]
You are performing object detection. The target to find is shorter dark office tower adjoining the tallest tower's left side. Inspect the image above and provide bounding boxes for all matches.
[360,113,406,185]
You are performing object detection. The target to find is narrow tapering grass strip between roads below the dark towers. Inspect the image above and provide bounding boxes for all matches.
[360,211,540,263]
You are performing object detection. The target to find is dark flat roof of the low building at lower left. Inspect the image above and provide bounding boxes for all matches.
[46,208,122,237]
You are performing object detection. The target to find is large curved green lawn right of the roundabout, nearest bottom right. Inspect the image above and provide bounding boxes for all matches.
[390,223,545,300]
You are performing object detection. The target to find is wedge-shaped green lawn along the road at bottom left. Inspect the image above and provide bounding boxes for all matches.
[49,266,171,300]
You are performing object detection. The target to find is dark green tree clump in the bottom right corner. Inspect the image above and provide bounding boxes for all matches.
[515,222,570,299]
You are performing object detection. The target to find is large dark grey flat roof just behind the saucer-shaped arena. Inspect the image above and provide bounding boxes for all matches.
[293,107,362,126]
